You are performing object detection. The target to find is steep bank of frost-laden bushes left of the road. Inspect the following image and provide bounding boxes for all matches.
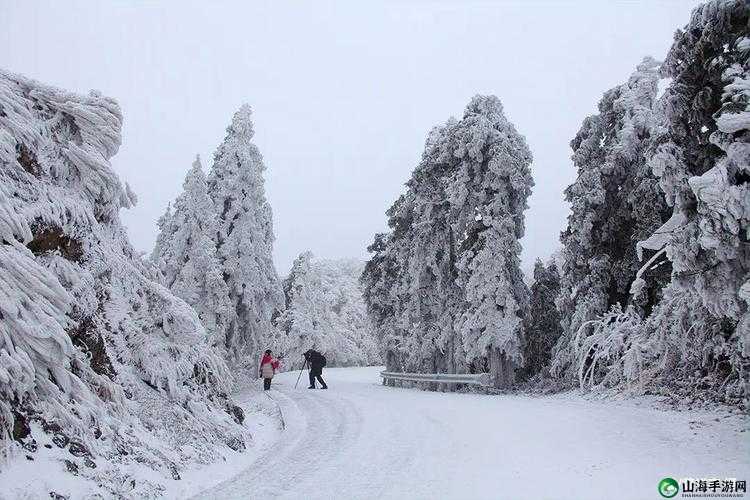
[0,72,244,496]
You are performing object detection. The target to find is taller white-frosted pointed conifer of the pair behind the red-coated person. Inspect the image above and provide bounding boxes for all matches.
[208,105,284,364]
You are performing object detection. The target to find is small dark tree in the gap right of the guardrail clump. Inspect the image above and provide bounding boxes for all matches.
[523,259,562,378]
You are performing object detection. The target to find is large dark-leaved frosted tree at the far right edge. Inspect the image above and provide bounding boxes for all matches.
[641,0,750,401]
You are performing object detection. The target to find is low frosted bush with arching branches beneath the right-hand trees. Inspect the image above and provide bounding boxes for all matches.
[571,286,743,404]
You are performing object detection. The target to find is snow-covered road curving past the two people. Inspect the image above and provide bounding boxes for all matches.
[198,368,750,499]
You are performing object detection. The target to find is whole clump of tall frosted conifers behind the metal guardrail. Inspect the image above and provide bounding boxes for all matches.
[362,96,533,386]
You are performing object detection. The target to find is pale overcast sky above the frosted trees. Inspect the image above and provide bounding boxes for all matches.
[0,0,696,275]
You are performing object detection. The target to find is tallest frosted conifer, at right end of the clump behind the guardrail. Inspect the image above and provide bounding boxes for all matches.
[447,96,534,386]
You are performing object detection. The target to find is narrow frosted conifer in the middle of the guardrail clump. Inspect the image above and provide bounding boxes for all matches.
[402,123,467,373]
